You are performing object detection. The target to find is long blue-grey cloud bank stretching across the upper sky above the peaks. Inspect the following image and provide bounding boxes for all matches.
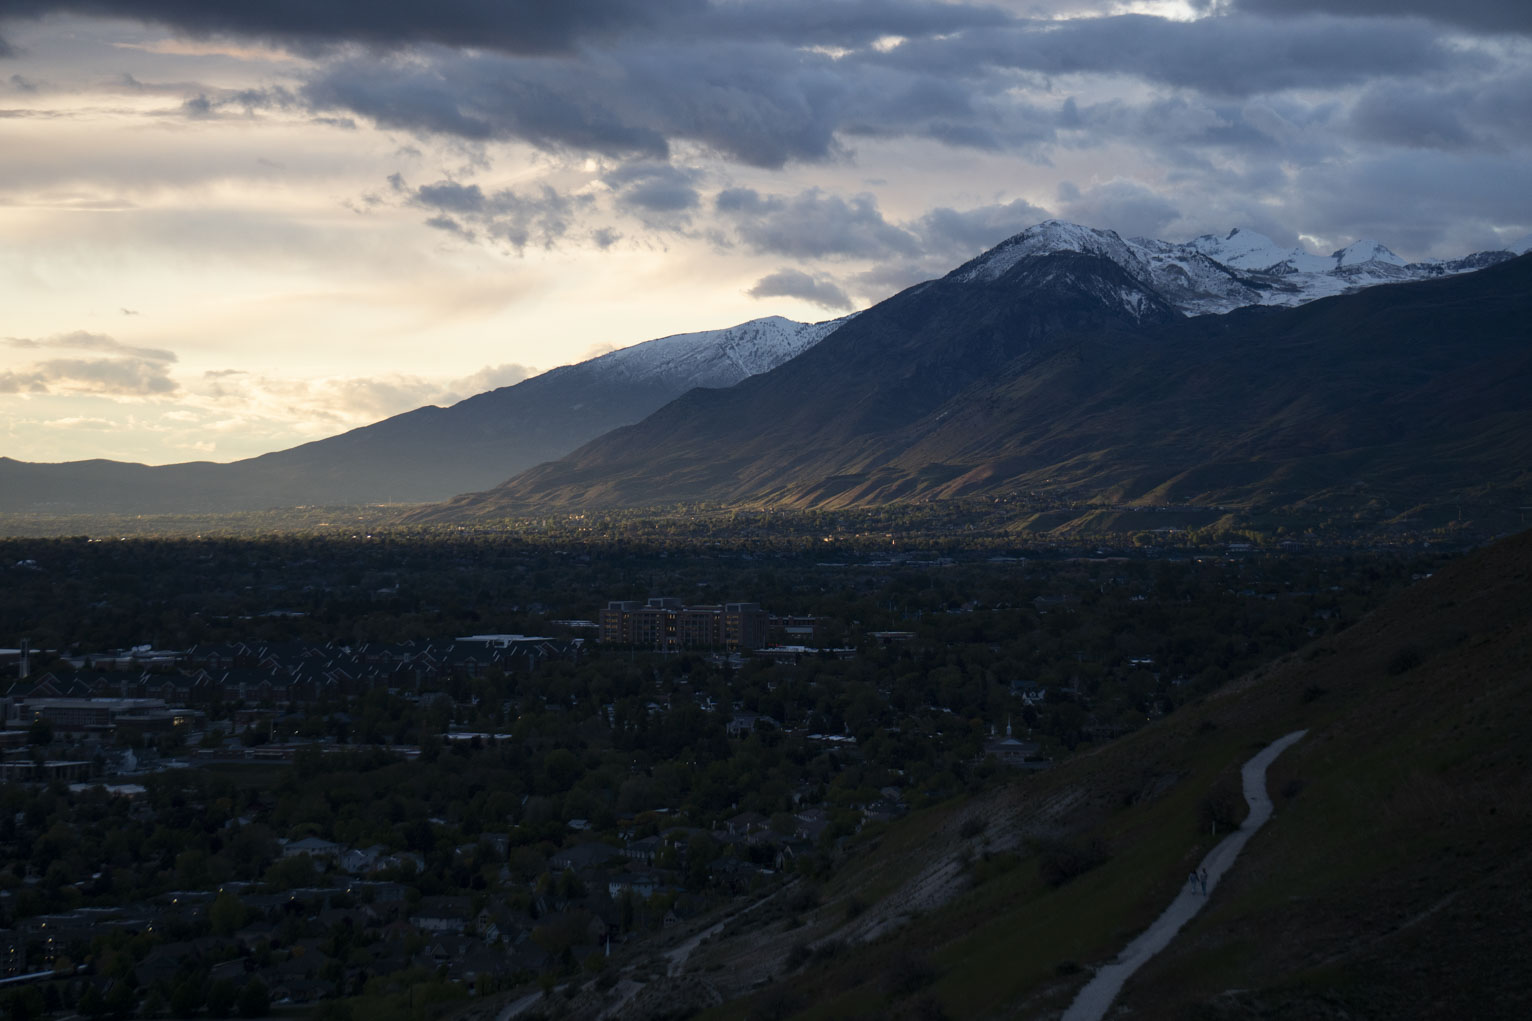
[284,5,1470,169]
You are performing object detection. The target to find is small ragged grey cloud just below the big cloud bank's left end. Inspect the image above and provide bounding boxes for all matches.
[401,173,588,251]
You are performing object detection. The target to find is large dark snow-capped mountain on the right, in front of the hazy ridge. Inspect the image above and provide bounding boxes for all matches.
[418,222,1532,520]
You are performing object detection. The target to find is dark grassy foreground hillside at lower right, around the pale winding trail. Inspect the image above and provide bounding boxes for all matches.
[703,533,1532,1018]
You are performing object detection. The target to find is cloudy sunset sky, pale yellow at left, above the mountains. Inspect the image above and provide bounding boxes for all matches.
[0,0,1532,463]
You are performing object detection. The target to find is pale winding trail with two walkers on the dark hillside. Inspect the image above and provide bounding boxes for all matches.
[1063,730,1308,1021]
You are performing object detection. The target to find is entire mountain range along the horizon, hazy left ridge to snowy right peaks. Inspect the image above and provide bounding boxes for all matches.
[0,221,1532,520]
